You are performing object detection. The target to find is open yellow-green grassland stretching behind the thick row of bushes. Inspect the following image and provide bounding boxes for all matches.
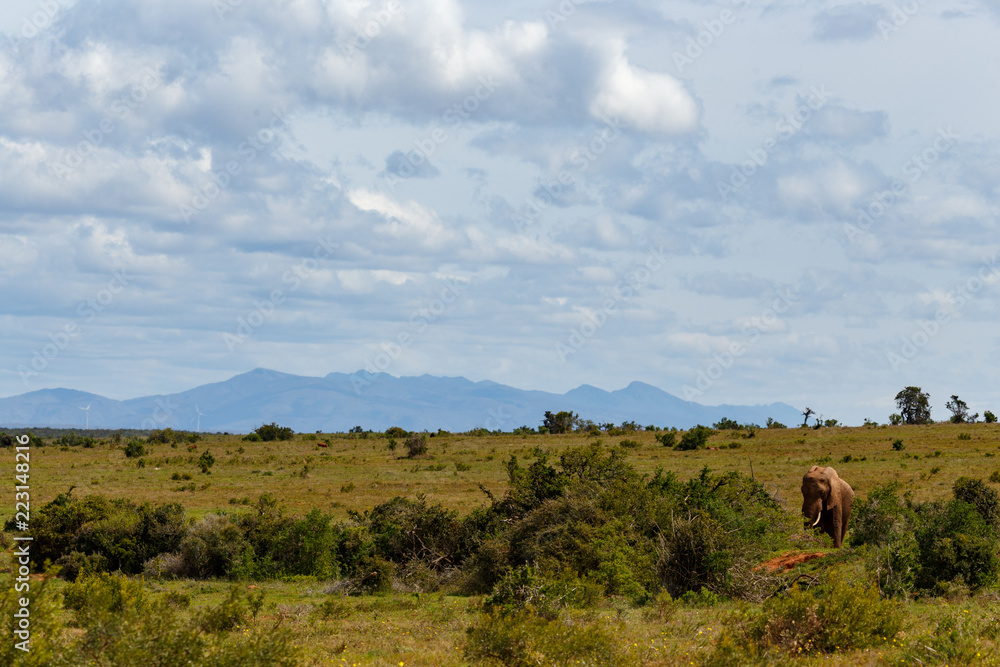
[9,424,1000,519]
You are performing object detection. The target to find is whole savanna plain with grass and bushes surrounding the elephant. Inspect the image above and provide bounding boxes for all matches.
[0,423,1000,667]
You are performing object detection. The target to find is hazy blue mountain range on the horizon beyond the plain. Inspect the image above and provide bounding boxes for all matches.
[0,368,801,433]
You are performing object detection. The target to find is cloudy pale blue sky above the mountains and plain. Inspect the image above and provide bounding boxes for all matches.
[0,0,1000,424]
